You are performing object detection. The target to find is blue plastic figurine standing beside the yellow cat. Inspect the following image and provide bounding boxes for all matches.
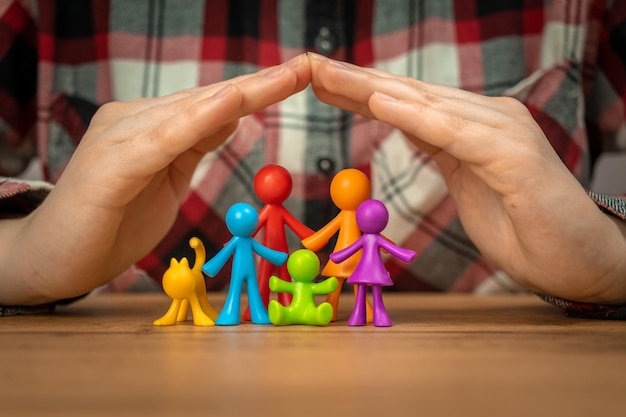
[202,203,287,326]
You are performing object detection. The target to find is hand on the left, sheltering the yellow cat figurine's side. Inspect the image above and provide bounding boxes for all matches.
[0,55,310,304]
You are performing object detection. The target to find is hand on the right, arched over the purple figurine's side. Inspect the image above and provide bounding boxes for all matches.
[309,54,626,303]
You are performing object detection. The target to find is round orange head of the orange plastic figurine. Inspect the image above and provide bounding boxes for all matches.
[330,168,371,210]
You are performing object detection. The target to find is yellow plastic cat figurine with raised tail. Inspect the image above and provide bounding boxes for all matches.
[154,237,217,326]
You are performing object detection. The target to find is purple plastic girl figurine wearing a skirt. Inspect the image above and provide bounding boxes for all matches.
[330,200,415,327]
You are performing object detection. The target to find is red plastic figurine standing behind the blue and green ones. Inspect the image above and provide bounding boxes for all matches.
[243,165,313,320]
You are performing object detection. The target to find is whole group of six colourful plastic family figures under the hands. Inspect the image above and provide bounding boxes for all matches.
[154,165,415,327]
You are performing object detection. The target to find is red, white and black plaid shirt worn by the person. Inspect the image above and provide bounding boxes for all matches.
[0,0,626,314]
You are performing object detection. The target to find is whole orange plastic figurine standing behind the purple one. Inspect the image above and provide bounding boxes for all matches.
[302,168,372,321]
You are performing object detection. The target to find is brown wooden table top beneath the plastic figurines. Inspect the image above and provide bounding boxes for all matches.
[0,294,626,417]
